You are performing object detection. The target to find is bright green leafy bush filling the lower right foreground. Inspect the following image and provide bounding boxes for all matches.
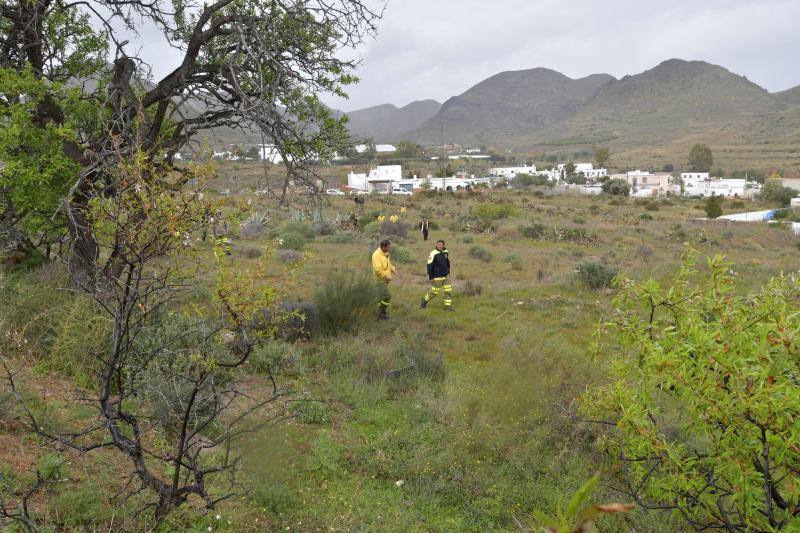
[581,251,800,531]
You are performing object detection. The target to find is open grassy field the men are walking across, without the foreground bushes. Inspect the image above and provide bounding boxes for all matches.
[0,183,798,531]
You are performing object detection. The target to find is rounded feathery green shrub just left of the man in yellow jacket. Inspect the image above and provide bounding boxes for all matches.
[314,272,378,335]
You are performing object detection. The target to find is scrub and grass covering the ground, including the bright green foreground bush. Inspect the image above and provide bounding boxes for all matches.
[0,178,800,531]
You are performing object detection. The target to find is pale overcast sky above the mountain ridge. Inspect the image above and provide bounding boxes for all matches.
[128,0,800,111]
